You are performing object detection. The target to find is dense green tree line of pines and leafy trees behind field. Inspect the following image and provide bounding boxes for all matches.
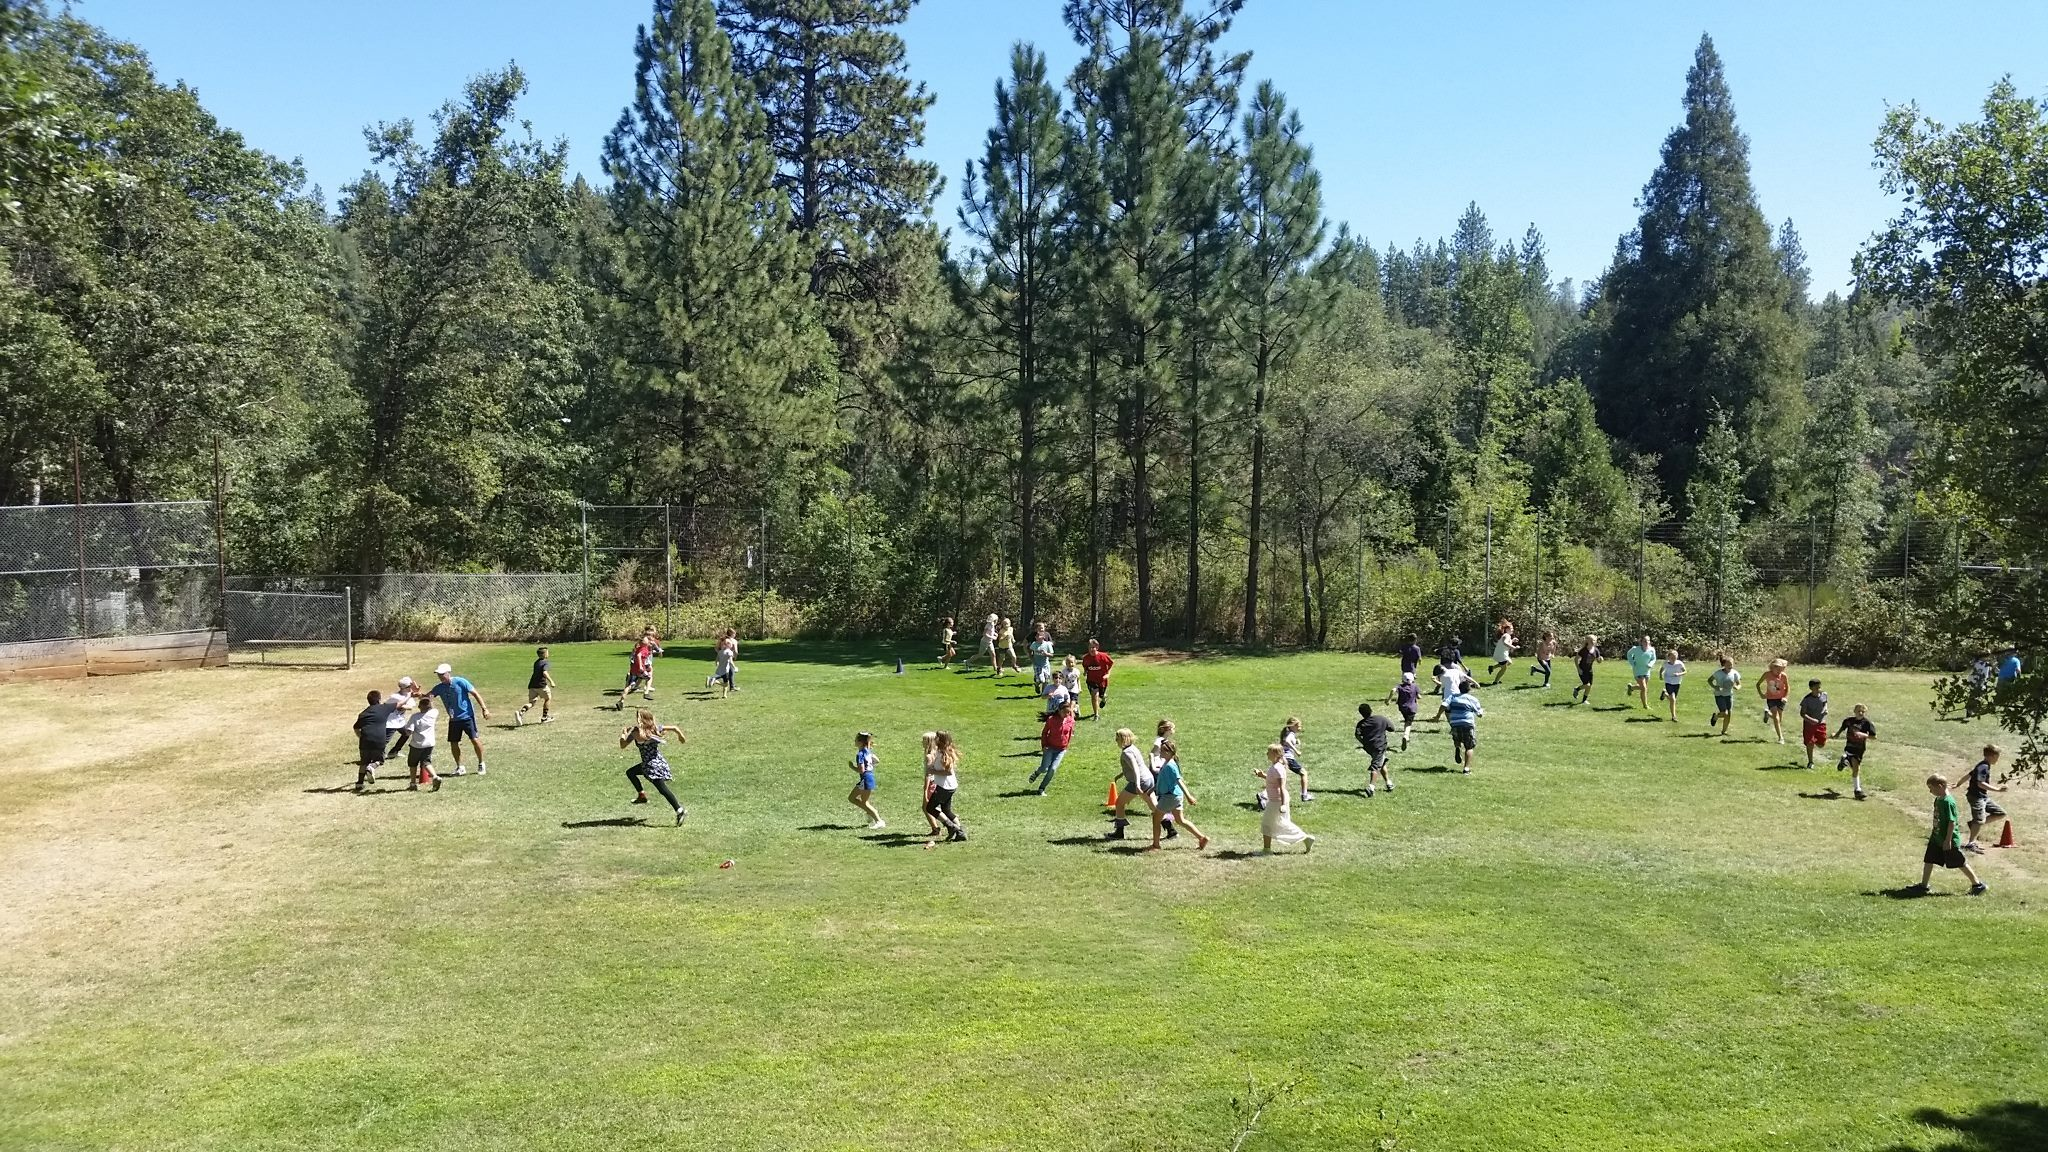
[0,0,2042,672]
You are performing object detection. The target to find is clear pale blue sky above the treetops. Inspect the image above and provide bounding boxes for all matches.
[76,0,2048,291]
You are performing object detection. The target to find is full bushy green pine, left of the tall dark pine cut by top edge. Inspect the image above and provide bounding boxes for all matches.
[594,0,829,504]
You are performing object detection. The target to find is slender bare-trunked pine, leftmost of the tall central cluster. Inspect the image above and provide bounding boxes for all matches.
[961,43,1065,621]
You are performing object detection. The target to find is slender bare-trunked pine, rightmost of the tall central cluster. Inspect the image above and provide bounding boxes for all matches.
[1237,84,1333,644]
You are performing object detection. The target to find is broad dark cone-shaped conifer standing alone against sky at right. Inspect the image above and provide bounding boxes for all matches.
[1593,37,1800,502]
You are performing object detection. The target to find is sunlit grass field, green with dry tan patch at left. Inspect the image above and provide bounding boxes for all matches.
[0,644,2048,1152]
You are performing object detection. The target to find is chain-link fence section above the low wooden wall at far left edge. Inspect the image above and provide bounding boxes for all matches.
[0,500,219,644]
